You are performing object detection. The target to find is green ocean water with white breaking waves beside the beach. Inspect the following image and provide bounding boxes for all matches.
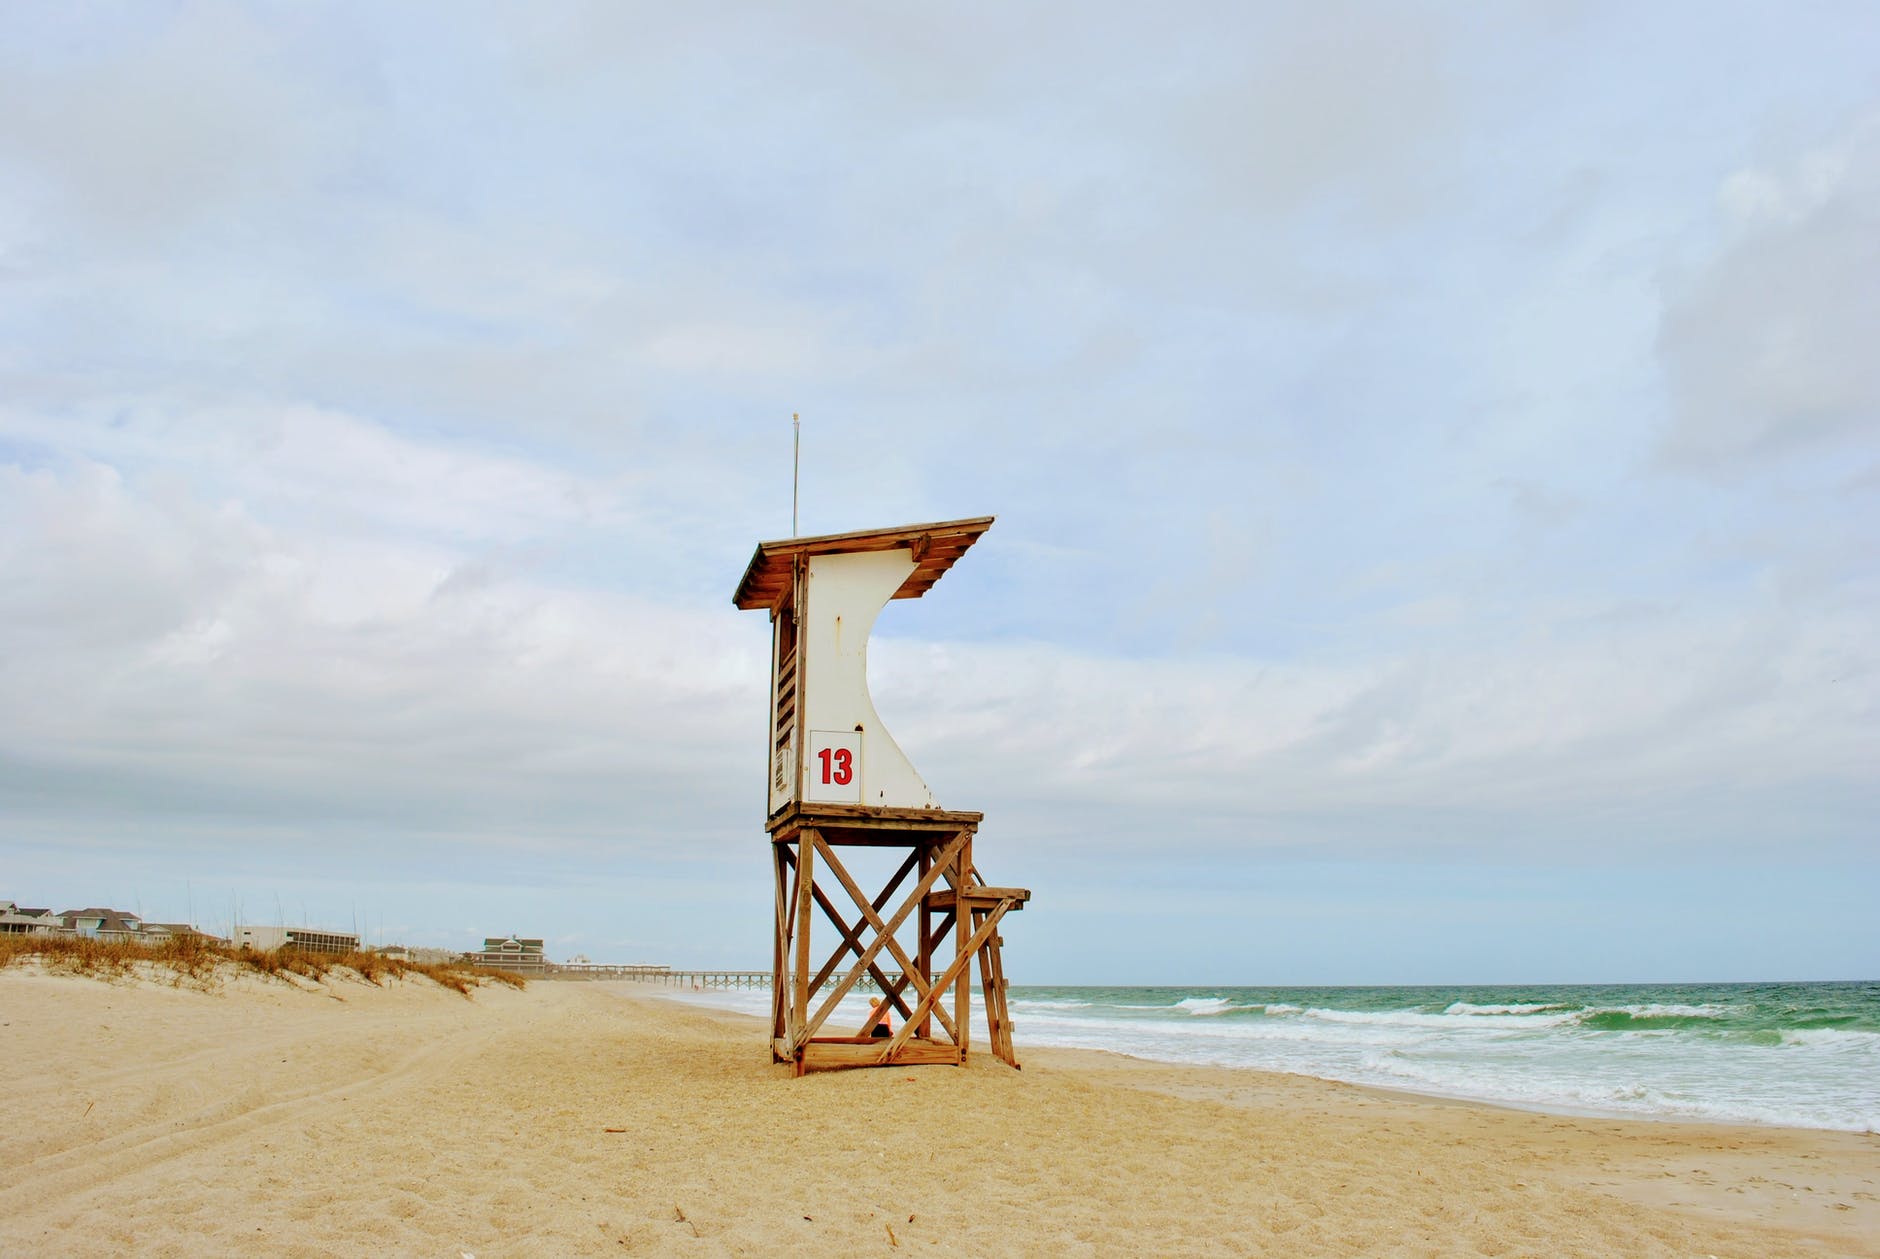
[661,983,1880,1131]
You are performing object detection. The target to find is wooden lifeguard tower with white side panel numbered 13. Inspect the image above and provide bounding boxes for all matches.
[733,517,1030,1075]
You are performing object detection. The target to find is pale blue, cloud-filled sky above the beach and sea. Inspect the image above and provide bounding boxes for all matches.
[0,0,1880,985]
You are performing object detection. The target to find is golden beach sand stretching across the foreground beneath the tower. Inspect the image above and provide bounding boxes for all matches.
[0,968,1880,1259]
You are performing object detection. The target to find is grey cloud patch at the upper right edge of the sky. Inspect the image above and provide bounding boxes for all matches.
[1658,117,1880,470]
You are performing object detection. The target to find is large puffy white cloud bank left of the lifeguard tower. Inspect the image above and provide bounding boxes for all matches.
[0,432,763,846]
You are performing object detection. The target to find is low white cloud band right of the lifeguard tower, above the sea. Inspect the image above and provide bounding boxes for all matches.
[874,586,1880,859]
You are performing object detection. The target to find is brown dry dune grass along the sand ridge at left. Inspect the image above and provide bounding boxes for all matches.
[0,936,526,996]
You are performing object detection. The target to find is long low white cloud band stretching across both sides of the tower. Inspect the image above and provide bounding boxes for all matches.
[11,413,1880,883]
